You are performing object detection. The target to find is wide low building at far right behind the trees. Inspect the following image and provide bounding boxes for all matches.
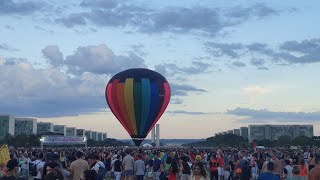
[249,124,313,142]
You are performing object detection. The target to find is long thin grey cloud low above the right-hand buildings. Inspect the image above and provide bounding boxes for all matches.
[226,107,320,122]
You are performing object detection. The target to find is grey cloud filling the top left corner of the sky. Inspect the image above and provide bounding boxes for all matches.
[0,0,45,15]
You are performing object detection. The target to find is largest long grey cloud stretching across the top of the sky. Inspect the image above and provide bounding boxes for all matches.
[56,0,278,35]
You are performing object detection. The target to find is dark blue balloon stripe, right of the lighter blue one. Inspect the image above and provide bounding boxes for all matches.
[143,83,159,134]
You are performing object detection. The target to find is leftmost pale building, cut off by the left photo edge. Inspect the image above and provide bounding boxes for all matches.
[0,115,15,140]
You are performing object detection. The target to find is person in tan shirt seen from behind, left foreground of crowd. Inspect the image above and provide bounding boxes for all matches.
[70,151,89,180]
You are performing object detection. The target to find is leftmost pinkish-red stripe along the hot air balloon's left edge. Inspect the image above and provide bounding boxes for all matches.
[106,83,130,134]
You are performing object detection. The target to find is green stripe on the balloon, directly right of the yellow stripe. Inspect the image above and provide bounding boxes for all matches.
[133,81,142,135]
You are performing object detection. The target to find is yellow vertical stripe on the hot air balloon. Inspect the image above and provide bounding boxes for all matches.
[124,78,137,134]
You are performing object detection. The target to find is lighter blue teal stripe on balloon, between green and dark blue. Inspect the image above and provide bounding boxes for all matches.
[140,78,151,134]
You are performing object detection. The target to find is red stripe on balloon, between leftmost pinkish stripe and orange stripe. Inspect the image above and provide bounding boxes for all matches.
[110,79,131,135]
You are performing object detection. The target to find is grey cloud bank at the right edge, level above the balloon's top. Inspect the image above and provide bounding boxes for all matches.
[204,38,320,66]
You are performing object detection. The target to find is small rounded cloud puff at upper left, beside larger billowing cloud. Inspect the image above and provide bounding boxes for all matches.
[42,45,63,67]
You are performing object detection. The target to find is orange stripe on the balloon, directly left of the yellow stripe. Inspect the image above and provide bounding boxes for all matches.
[116,83,134,135]
